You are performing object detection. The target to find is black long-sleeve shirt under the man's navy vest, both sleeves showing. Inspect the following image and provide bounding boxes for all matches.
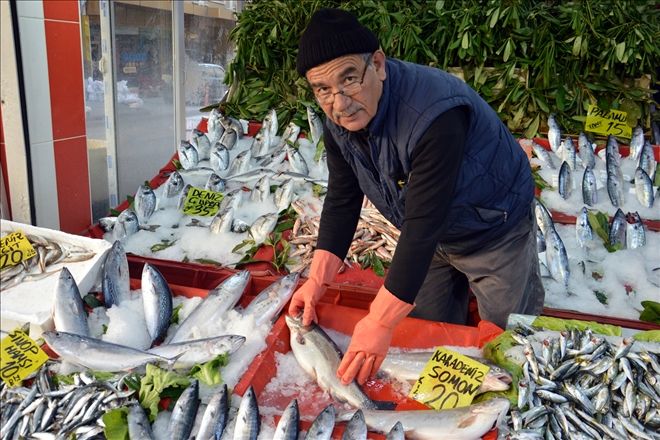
[317,107,469,303]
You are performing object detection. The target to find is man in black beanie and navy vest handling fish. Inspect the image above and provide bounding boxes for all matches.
[289,9,544,383]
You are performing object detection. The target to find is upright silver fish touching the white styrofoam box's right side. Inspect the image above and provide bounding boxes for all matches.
[53,267,89,336]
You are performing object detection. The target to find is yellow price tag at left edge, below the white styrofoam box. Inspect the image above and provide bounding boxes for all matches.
[0,329,48,386]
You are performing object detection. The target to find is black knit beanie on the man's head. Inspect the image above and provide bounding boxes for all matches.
[296,8,379,76]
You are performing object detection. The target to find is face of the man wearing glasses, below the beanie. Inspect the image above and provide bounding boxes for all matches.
[306,50,386,131]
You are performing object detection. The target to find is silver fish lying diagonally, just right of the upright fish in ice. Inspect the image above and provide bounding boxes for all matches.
[165,270,250,344]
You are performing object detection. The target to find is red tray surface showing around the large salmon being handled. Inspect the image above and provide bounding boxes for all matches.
[234,303,502,439]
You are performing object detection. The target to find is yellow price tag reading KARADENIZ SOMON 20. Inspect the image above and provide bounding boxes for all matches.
[409,347,490,409]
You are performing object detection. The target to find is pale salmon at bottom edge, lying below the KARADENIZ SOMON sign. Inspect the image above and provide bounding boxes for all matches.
[338,397,510,440]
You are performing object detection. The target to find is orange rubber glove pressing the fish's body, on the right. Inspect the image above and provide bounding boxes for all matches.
[337,286,415,385]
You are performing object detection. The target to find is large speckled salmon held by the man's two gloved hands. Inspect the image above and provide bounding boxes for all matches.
[284,315,391,410]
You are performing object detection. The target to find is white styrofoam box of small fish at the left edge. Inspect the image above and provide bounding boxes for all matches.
[0,220,112,338]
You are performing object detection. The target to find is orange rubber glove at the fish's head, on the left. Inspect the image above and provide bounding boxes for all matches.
[289,249,343,326]
